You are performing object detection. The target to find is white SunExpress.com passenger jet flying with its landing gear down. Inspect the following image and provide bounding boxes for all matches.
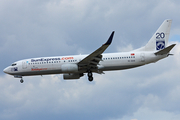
[3,19,176,83]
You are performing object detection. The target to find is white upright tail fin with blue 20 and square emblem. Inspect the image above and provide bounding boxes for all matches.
[138,20,172,51]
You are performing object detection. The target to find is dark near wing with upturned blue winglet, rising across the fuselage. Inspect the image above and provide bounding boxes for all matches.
[78,31,114,70]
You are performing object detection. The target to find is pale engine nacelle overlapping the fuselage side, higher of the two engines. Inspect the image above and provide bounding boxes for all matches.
[61,64,78,73]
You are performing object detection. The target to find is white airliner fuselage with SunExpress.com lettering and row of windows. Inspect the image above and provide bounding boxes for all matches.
[4,51,167,77]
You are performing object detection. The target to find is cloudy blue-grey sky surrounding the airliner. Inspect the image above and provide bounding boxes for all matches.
[0,0,180,120]
